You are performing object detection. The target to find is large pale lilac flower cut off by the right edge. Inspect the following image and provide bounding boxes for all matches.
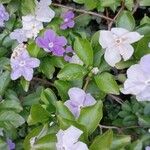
[121,54,150,101]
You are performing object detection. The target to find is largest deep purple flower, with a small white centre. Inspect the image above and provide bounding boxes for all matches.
[36,29,67,56]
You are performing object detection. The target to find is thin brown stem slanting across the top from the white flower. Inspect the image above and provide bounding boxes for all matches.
[51,3,113,22]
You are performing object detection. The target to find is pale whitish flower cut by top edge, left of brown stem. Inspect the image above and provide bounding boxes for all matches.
[35,0,55,22]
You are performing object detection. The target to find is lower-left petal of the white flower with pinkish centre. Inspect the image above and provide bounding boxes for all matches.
[104,47,121,67]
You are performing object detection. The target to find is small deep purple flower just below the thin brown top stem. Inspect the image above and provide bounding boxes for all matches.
[60,11,75,30]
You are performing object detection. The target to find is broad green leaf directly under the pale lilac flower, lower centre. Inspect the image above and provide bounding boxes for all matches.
[77,101,103,135]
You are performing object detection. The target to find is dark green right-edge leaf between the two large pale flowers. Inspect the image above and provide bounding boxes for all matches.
[134,35,150,59]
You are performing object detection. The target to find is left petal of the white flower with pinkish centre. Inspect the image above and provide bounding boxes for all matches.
[99,30,114,48]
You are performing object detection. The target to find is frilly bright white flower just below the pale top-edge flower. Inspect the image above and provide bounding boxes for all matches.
[22,15,43,38]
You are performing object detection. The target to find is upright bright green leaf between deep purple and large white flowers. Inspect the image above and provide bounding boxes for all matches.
[74,38,93,66]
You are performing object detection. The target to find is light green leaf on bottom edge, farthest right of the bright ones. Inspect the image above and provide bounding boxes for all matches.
[111,135,131,150]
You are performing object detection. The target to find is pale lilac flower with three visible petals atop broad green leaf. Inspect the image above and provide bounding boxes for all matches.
[64,87,96,118]
